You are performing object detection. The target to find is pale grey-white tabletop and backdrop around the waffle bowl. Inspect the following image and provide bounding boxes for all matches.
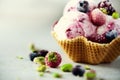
[0,0,120,80]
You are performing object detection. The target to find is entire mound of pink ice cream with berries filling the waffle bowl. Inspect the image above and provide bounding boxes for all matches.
[54,0,120,43]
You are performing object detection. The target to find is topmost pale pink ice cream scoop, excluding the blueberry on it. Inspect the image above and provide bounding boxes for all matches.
[63,0,97,14]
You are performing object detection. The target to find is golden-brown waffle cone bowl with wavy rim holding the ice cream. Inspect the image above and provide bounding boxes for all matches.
[52,31,120,64]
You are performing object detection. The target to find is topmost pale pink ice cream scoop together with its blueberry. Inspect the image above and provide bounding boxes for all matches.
[63,0,97,14]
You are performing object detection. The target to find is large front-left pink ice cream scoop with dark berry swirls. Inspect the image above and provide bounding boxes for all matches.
[54,11,96,39]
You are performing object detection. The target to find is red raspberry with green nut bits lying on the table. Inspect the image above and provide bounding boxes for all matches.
[45,52,62,68]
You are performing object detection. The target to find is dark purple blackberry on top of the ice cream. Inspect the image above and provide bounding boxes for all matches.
[98,0,115,15]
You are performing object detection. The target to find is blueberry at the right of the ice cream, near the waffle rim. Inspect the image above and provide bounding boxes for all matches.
[105,30,118,41]
